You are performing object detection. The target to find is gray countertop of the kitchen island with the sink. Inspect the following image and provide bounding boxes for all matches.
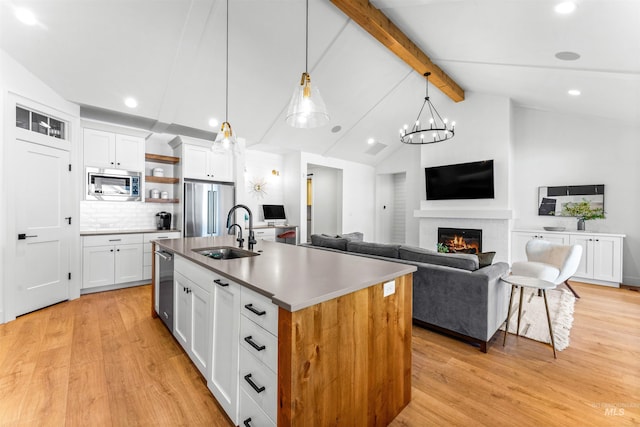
[155,236,416,311]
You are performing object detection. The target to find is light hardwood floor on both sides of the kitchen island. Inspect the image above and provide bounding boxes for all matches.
[0,284,640,426]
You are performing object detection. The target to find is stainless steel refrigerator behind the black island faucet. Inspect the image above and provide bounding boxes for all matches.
[184,181,235,237]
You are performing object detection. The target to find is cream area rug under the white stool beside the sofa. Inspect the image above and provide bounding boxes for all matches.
[500,287,576,351]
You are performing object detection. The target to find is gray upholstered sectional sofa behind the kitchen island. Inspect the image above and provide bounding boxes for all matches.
[301,233,510,353]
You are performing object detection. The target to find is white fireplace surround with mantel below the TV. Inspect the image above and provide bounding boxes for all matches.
[413,209,513,262]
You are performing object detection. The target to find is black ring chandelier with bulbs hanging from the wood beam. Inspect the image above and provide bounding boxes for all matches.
[400,72,456,144]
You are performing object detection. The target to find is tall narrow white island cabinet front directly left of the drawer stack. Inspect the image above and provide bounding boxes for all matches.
[207,277,240,424]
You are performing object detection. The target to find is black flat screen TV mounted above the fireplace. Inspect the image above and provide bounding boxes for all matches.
[424,160,495,200]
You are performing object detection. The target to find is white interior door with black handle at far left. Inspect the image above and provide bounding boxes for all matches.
[12,140,71,316]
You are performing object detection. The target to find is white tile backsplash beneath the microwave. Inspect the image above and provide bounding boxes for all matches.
[80,201,179,231]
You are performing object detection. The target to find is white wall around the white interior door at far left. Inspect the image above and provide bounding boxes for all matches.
[0,50,80,323]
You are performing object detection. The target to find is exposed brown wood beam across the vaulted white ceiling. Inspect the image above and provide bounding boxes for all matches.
[331,0,464,102]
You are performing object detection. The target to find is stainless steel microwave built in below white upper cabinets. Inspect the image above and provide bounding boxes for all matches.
[85,168,142,201]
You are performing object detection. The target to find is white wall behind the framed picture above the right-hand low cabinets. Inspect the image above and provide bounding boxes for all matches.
[513,108,640,286]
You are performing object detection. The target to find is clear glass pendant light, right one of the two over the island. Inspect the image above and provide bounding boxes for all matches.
[286,0,329,129]
